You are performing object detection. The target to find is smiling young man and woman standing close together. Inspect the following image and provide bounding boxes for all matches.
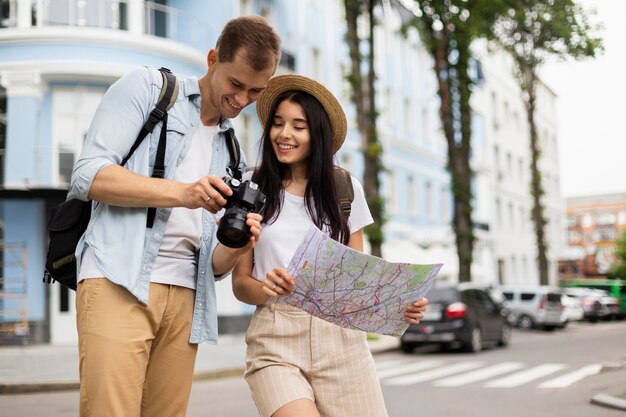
[70,16,427,417]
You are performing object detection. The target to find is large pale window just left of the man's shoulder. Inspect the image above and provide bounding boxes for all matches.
[52,86,104,186]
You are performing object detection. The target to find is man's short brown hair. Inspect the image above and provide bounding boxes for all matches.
[215,16,280,71]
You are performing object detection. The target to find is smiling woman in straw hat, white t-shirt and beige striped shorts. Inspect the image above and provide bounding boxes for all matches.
[233,75,427,417]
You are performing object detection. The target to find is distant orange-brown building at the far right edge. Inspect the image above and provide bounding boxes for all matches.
[559,193,626,279]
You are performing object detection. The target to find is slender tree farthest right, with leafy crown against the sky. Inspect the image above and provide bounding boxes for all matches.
[492,0,602,285]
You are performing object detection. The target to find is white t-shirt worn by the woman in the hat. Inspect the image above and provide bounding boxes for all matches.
[252,177,374,280]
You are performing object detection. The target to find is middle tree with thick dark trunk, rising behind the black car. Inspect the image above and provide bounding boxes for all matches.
[400,0,502,282]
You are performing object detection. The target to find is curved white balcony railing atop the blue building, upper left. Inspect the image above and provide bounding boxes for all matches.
[0,0,209,45]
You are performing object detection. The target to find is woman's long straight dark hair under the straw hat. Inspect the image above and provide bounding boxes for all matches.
[252,91,350,245]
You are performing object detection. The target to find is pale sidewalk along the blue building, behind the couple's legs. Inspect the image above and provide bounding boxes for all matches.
[0,334,399,395]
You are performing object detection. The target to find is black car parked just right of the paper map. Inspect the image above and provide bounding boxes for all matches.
[400,284,511,353]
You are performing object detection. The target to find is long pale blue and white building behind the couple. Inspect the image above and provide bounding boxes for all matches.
[0,0,562,343]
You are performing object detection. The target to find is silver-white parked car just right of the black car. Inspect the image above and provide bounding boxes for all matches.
[500,286,567,330]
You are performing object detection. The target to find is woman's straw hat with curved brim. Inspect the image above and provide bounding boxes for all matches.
[256,74,348,153]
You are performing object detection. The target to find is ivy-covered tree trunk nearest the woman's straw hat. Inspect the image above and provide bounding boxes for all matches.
[344,0,385,257]
